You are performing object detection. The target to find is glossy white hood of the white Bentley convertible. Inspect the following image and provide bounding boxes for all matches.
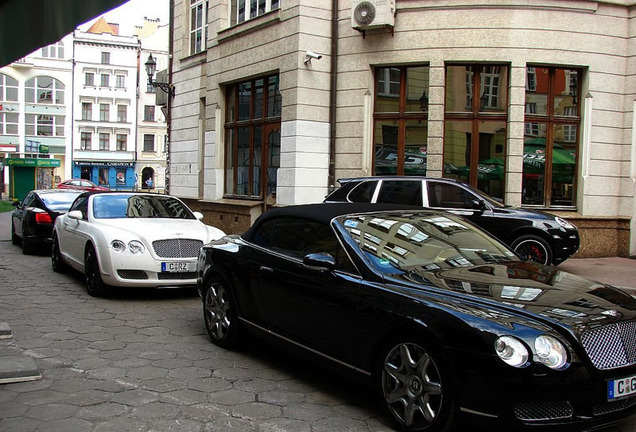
[94,218,224,243]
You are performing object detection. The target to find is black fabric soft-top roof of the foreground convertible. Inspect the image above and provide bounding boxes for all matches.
[241,203,428,239]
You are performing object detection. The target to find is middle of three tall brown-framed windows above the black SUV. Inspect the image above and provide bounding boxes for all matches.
[444,65,509,199]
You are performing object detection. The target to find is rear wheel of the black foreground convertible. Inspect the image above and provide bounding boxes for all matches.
[203,279,243,348]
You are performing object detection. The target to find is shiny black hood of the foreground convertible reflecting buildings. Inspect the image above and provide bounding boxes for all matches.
[390,261,636,334]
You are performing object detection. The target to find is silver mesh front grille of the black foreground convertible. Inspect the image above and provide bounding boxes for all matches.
[581,321,636,369]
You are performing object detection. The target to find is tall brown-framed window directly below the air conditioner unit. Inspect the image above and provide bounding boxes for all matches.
[373,66,429,175]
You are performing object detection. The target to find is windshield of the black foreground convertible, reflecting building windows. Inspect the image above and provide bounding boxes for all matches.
[338,213,519,273]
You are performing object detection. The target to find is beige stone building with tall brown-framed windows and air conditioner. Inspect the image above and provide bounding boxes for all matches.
[169,0,636,256]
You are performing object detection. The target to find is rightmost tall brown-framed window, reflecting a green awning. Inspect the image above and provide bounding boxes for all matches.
[521,66,582,208]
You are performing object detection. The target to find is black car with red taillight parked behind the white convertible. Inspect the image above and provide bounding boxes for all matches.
[11,189,81,254]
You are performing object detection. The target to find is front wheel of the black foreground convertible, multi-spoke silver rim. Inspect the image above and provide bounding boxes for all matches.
[377,337,457,432]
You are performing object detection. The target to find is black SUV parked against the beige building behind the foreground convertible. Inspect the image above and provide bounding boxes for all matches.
[325,176,580,265]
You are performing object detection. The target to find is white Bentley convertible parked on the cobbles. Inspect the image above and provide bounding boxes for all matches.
[51,192,224,296]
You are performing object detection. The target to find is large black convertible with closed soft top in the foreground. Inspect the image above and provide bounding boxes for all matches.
[197,204,636,432]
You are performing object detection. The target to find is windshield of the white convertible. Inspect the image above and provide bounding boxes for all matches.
[93,194,196,219]
